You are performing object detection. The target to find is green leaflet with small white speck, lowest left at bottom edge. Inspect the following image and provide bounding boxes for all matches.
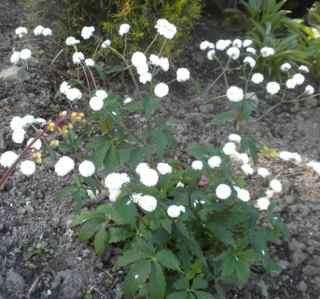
[123,260,151,297]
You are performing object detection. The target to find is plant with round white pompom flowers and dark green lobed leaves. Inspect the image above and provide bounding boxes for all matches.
[0,19,320,299]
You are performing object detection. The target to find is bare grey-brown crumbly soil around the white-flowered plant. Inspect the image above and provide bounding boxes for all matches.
[0,0,320,299]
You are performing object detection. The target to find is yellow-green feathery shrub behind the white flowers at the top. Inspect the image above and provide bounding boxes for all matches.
[25,0,202,54]
